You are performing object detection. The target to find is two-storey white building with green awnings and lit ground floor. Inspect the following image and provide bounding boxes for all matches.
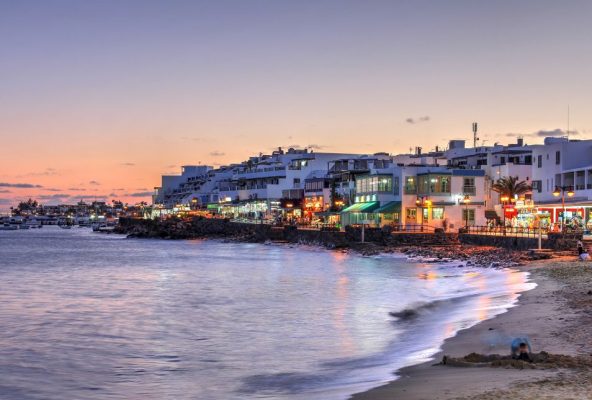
[342,165,487,230]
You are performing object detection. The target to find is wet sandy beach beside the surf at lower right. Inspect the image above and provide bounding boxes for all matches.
[352,257,592,400]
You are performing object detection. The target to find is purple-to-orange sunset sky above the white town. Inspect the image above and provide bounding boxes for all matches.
[0,0,592,209]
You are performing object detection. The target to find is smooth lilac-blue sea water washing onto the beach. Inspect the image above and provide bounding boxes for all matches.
[0,227,533,400]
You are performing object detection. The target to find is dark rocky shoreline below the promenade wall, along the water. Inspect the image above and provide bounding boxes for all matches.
[114,218,564,268]
